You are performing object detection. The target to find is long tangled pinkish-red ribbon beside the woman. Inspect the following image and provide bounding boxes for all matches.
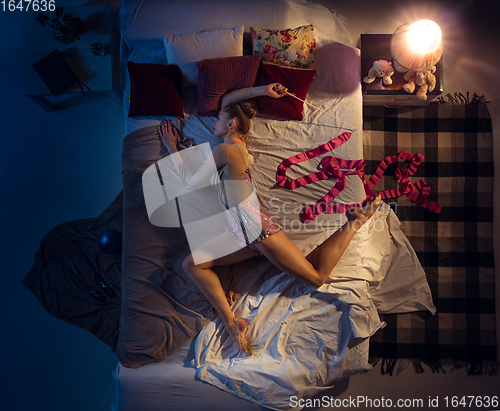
[276,132,441,223]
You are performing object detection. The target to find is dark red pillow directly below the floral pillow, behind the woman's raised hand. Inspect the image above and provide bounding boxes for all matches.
[257,63,316,120]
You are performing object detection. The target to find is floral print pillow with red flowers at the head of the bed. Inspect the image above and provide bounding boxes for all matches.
[250,25,316,69]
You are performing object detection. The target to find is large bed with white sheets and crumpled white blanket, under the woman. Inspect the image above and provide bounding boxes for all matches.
[113,0,434,411]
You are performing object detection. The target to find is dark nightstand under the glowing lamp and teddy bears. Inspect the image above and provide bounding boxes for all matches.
[361,34,443,107]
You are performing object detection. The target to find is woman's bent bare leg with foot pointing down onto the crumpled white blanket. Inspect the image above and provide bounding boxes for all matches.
[182,243,259,355]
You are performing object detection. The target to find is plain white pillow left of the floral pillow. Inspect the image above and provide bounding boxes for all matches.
[163,26,243,87]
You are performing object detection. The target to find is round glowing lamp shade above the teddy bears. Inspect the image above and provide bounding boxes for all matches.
[391,20,443,72]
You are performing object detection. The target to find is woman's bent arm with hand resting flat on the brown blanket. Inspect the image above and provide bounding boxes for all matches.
[159,120,228,189]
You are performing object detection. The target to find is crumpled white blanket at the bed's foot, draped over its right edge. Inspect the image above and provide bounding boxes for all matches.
[195,203,435,409]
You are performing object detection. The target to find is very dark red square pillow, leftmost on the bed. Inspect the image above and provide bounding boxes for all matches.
[127,61,184,118]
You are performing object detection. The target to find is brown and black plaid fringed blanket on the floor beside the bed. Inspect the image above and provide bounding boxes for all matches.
[363,104,498,374]
